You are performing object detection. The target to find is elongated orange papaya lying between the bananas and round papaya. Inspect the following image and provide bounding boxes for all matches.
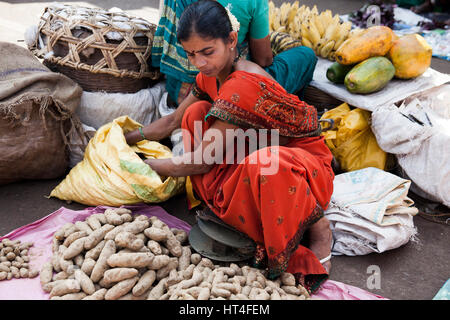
[335,26,395,65]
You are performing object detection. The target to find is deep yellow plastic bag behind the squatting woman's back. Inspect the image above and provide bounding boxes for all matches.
[321,103,387,171]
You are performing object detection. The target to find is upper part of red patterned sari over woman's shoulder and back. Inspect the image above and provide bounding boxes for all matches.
[193,71,320,138]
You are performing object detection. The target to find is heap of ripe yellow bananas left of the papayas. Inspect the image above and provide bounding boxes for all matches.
[269,1,352,61]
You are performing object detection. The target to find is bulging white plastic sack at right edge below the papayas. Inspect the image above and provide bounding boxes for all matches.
[371,84,450,207]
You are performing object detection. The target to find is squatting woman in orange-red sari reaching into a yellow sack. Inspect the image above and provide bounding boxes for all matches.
[126,0,334,292]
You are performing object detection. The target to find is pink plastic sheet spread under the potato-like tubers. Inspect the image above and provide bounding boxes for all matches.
[0,204,384,300]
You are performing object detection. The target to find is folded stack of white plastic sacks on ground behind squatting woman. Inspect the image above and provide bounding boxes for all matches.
[325,168,418,256]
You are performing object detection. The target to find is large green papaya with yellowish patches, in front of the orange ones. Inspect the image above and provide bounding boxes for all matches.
[344,57,395,94]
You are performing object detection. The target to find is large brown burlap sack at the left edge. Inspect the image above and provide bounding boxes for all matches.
[0,42,82,184]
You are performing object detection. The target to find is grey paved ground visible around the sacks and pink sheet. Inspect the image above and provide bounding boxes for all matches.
[0,0,450,300]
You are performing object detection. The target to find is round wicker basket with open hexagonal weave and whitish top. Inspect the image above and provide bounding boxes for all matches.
[29,3,161,93]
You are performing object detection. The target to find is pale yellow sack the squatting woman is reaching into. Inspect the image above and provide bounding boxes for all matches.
[50,116,186,206]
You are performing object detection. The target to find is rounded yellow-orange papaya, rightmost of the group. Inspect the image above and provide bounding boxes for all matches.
[387,34,433,79]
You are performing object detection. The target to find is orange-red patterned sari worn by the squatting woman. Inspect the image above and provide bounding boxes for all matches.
[182,71,334,292]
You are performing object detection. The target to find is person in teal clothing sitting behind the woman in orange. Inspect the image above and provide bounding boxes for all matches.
[151,0,317,106]
